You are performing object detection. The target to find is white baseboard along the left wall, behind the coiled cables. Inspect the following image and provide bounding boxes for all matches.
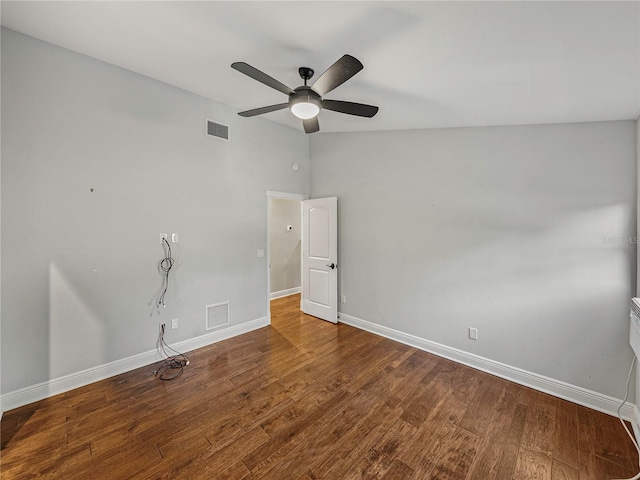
[0,317,269,411]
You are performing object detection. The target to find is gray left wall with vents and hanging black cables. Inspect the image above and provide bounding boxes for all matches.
[1,29,309,393]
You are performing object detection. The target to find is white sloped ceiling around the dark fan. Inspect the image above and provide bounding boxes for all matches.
[1,1,640,132]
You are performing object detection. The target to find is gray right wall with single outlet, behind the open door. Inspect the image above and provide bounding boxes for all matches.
[311,121,636,398]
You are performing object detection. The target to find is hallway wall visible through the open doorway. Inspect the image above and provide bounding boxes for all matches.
[269,198,302,293]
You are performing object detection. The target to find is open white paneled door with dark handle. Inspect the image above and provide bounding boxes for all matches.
[300,197,338,323]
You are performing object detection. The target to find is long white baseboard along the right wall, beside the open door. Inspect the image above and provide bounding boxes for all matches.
[338,313,640,423]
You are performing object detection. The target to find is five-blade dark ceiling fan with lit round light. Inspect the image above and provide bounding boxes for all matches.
[231,55,378,133]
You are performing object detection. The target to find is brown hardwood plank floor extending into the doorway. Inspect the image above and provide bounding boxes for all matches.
[0,295,638,480]
